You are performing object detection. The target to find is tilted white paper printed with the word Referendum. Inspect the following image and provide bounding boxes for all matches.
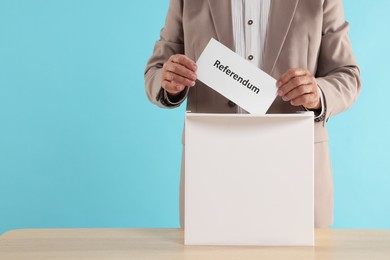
[197,38,277,114]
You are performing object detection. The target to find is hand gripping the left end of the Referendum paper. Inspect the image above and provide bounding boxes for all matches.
[161,54,197,96]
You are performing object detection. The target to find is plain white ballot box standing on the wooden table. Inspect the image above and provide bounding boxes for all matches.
[184,112,314,246]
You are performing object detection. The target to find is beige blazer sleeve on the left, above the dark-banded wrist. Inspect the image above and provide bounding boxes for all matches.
[144,0,188,108]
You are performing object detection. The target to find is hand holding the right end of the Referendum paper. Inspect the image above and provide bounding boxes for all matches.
[276,69,321,109]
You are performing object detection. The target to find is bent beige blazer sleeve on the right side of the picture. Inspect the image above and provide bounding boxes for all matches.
[316,0,361,121]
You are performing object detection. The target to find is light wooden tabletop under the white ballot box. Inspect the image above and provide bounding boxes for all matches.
[0,229,390,260]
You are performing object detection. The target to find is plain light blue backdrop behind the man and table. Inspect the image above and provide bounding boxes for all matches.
[0,0,390,233]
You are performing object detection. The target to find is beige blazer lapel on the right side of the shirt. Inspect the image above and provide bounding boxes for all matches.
[262,0,299,75]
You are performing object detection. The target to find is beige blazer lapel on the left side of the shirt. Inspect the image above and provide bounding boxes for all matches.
[209,0,235,51]
